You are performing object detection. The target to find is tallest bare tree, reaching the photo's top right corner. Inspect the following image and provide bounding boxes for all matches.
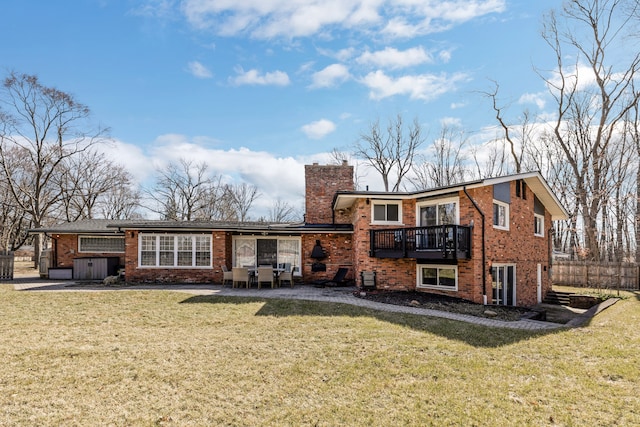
[543,0,640,259]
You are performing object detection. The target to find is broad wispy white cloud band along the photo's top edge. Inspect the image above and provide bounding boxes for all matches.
[182,0,506,39]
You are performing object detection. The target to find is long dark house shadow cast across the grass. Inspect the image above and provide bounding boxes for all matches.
[181,295,564,348]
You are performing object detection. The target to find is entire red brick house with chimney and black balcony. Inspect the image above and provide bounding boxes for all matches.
[34,162,567,306]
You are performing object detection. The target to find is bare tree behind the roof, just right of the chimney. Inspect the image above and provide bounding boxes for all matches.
[355,114,424,191]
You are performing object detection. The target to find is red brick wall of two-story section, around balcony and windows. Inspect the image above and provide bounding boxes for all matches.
[353,182,551,306]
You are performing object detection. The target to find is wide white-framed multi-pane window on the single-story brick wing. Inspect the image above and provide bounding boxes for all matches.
[138,233,211,268]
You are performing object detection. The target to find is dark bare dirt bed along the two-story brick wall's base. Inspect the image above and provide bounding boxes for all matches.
[354,291,538,321]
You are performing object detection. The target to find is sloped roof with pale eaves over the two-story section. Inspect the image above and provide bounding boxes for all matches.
[333,172,569,220]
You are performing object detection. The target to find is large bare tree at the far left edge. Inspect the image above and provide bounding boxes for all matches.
[0,72,106,266]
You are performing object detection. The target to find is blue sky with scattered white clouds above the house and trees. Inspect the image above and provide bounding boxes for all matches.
[0,0,561,217]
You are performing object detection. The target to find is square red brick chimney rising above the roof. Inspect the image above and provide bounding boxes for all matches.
[304,160,354,224]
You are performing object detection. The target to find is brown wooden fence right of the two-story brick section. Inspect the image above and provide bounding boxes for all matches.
[551,261,640,290]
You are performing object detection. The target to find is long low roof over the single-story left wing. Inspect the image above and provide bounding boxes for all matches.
[29,219,353,235]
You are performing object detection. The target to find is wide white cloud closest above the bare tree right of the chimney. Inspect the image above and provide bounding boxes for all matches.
[362,71,469,101]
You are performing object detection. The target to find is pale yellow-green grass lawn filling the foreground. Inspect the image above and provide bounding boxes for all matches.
[0,285,640,426]
